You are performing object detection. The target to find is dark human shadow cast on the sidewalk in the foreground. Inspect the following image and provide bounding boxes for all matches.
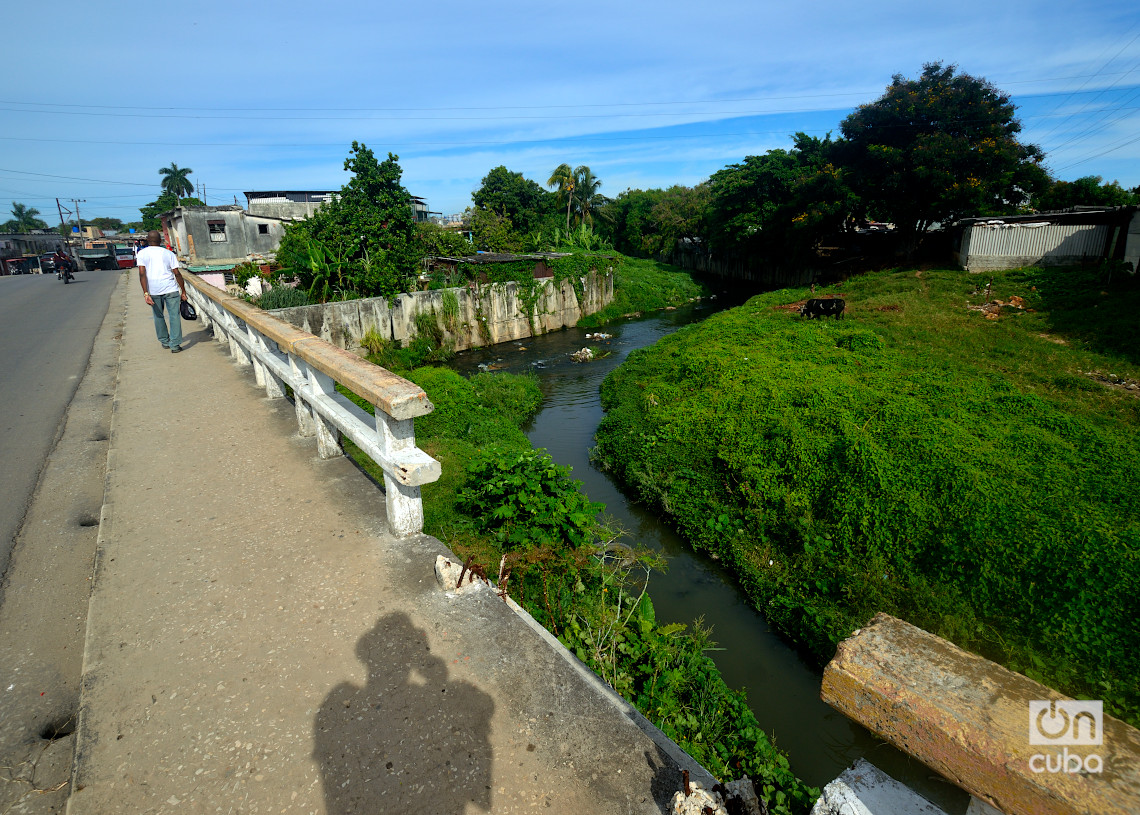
[314,613,495,815]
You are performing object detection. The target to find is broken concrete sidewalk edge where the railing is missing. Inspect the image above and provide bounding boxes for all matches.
[434,553,717,789]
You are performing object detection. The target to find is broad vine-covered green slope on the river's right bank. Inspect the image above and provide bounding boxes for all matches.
[595,269,1140,723]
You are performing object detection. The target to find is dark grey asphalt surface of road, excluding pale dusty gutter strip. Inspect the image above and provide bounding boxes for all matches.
[0,271,121,600]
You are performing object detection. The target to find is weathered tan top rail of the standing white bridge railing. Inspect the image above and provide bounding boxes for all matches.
[182,271,434,419]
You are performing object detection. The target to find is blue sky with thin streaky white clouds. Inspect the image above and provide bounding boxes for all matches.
[0,0,1140,222]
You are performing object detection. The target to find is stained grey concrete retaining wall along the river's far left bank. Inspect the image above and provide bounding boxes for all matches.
[271,272,613,353]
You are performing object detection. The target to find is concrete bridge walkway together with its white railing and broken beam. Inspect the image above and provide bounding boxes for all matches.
[0,275,1140,815]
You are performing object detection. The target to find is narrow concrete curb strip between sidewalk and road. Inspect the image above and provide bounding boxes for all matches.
[64,276,130,813]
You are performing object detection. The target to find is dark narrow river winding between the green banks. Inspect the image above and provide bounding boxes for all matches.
[451,295,967,813]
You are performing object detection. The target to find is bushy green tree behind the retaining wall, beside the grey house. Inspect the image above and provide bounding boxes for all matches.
[277,141,420,300]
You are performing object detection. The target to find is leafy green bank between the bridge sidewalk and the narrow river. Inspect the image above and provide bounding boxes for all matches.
[345,357,817,814]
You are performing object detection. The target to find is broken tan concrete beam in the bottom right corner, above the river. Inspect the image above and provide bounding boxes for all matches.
[821,614,1140,815]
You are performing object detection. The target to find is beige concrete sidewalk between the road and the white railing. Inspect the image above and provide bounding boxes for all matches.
[68,282,702,815]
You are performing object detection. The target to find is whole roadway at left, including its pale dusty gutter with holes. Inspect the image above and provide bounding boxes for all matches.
[0,271,125,815]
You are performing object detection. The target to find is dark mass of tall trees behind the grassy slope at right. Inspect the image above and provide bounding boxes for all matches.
[597,63,1140,268]
